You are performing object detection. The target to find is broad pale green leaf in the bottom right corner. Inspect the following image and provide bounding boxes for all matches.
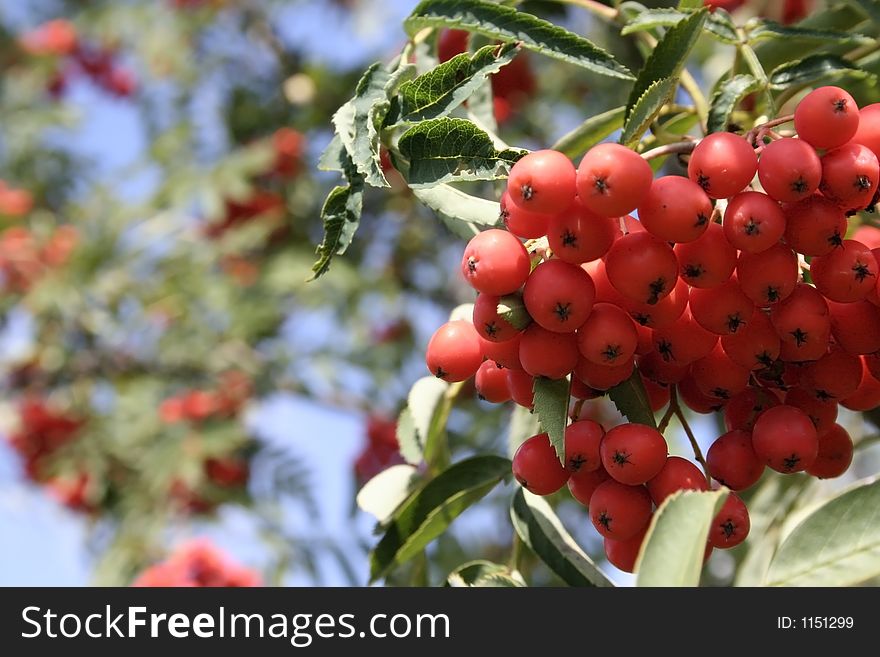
[767,480,880,586]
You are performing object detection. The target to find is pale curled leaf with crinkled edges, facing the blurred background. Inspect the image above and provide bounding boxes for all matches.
[333,62,391,187]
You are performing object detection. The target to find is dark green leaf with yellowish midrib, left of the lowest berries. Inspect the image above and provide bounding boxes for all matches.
[370,456,510,582]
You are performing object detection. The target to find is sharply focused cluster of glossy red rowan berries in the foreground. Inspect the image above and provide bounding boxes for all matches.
[426,87,880,570]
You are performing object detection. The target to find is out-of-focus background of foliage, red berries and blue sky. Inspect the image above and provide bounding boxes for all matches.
[0,0,877,585]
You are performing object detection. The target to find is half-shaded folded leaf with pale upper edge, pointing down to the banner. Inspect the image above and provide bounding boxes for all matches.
[510,488,614,587]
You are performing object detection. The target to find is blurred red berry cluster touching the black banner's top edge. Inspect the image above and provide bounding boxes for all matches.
[132,540,261,587]
